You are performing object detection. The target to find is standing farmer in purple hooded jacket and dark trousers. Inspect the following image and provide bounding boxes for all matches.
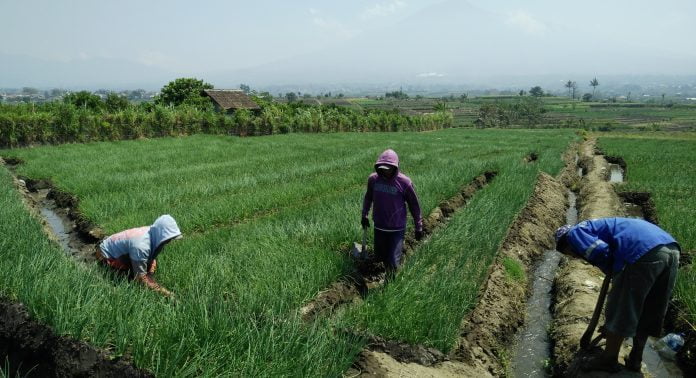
[361,150,423,275]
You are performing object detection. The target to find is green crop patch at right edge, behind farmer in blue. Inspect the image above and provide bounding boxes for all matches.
[600,134,696,334]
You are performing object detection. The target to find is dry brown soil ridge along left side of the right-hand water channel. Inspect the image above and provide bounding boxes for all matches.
[345,173,566,377]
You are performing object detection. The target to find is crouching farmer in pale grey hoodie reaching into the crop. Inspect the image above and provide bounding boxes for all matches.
[96,215,182,297]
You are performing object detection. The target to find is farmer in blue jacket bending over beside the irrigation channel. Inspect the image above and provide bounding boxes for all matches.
[556,218,680,373]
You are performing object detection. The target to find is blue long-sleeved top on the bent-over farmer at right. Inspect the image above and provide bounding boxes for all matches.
[567,218,677,273]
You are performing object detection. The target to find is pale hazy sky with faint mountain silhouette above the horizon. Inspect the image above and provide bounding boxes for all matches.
[0,0,696,87]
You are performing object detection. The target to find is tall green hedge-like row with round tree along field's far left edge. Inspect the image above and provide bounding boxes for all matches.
[0,79,453,147]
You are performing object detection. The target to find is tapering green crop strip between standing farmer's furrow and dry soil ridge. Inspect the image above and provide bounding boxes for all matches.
[345,139,568,352]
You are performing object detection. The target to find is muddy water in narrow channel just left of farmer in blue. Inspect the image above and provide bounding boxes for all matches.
[512,191,578,377]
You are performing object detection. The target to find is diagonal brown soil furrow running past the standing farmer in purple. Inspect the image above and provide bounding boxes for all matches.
[300,172,496,322]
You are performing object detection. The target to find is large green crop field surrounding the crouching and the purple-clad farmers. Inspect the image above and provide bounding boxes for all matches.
[0,129,575,376]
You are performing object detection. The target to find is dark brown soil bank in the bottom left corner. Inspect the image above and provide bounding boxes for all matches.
[0,299,152,378]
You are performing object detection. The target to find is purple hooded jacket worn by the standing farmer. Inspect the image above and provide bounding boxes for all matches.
[362,150,423,231]
